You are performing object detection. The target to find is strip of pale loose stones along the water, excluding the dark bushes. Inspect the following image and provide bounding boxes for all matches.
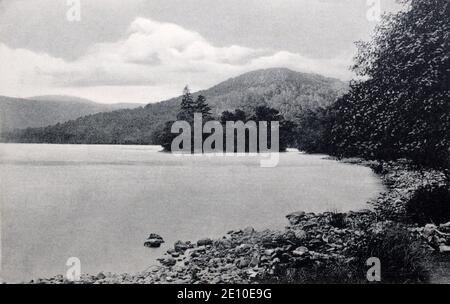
[32,159,450,284]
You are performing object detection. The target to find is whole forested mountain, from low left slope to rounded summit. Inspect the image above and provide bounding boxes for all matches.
[3,68,348,144]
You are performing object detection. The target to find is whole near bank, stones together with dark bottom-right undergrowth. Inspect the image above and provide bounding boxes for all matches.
[31,159,450,284]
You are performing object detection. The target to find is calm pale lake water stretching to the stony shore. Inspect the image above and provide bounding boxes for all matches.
[0,144,382,282]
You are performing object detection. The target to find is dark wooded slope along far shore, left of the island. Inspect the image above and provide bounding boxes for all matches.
[0,103,178,145]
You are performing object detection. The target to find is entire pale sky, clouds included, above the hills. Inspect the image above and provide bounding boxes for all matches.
[0,0,399,103]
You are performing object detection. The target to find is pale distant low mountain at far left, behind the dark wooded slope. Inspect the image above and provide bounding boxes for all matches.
[0,95,141,132]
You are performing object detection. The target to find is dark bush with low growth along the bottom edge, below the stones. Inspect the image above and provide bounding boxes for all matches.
[260,224,428,284]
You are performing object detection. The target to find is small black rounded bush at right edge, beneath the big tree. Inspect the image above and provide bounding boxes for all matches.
[406,184,450,225]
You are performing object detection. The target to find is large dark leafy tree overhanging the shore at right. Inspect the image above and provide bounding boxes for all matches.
[332,0,450,168]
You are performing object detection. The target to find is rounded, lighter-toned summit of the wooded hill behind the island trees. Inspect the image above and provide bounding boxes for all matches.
[158,68,348,119]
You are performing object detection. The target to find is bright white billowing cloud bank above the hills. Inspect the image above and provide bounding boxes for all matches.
[0,18,352,102]
